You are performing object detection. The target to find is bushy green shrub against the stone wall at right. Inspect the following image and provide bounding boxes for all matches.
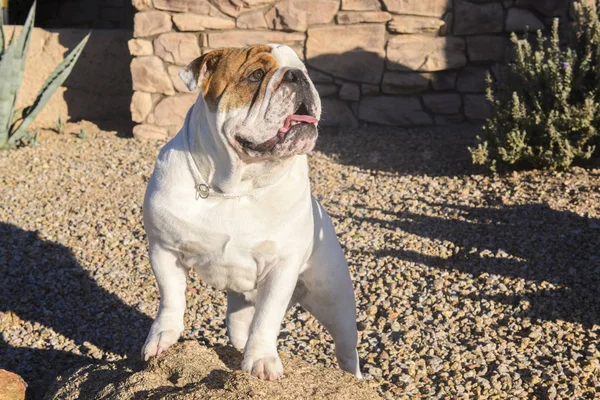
[469,2,600,170]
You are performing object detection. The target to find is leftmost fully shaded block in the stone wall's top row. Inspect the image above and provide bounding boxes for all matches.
[454,0,504,35]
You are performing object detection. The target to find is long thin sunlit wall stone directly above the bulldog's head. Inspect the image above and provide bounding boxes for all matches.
[208,30,305,49]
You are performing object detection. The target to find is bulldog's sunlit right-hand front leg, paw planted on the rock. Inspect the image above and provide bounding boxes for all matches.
[242,264,298,380]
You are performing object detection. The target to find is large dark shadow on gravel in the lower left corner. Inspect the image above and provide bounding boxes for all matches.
[0,223,152,399]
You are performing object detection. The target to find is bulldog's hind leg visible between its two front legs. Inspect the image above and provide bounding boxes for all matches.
[227,291,254,350]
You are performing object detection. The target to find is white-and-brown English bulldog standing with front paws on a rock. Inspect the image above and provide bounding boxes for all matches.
[142,45,361,380]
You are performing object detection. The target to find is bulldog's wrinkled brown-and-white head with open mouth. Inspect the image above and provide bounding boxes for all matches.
[180,45,321,159]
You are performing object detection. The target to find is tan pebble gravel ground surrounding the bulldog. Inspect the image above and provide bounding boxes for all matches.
[0,124,600,399]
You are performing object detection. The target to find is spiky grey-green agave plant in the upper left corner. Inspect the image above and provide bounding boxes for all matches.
[0,2,90,149]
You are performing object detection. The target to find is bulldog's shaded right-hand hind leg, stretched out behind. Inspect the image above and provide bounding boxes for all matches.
[295,200,362,378]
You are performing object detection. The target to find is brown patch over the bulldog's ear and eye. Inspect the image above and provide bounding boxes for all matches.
[179,45,277,111]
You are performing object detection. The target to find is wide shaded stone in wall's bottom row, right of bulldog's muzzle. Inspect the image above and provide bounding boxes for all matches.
[358,96,433,126]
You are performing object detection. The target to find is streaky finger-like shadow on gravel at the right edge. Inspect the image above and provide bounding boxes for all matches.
[358,204,600,328]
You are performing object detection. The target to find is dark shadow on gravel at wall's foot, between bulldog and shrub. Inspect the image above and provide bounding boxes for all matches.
[316,124,482,176]
